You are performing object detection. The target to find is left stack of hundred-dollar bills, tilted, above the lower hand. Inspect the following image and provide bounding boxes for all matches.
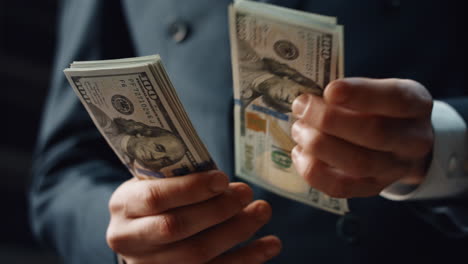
[64,55,216,179]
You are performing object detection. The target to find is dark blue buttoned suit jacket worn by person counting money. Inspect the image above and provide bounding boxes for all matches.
[31,0,468,264]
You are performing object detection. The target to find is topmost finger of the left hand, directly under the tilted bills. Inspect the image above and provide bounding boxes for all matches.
[109,170,229,218]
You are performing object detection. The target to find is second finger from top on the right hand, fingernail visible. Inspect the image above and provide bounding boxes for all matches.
[293,95,433,157]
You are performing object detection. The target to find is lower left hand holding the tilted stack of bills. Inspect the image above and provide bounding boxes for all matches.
[107,171,281,264]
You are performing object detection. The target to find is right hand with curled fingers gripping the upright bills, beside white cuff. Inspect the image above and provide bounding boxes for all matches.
[291,78,434,198]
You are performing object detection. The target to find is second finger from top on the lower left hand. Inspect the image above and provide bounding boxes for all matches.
[120,183,253,253]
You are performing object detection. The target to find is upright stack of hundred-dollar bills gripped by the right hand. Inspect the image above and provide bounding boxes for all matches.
[229,0,349,214]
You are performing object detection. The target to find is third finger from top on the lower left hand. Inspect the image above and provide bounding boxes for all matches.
[149,201,271,263]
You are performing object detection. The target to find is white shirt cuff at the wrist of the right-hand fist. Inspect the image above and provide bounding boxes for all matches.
[380,101,468,201]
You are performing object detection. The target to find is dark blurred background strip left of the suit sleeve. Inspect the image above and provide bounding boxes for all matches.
[0,0,61,264]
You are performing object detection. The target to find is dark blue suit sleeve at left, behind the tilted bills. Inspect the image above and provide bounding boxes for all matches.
[30,0,131,263]
